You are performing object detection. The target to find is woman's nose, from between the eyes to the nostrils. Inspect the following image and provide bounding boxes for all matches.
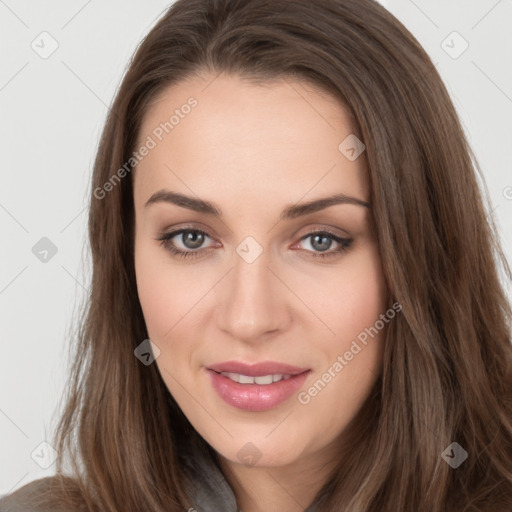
[216,245,291,343]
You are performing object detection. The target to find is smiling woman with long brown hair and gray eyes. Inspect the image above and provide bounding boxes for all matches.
[0,0,512,512]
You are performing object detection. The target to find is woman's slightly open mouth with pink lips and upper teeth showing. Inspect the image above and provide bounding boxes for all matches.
[206,361,311,412]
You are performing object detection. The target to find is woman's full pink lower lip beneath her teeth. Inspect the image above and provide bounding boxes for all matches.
[207,370,310,411]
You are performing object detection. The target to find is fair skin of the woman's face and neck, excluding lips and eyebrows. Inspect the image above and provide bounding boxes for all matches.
[134,75,387,512]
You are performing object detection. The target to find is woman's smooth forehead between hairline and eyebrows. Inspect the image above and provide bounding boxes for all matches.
[130,75,366,210]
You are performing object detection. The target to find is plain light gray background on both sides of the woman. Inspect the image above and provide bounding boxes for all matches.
[0,0,512,495]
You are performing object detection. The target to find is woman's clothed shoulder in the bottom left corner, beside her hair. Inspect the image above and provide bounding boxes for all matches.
[0,475,87,512]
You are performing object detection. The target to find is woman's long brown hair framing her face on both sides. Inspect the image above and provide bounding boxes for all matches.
[14,0,512,512]
